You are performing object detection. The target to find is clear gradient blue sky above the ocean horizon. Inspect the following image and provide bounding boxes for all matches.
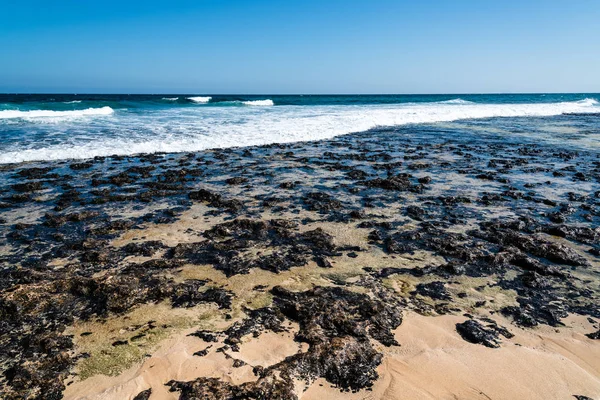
[0,0,600,93]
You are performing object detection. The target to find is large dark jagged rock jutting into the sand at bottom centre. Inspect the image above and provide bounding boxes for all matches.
[168,286,402,399]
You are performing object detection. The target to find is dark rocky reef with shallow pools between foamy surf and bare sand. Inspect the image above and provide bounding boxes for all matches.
[0,115,600,399]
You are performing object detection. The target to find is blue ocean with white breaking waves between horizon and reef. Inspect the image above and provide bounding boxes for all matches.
[0,93,600,164]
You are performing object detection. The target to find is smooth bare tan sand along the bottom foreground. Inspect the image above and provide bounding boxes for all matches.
[65,313,600,400]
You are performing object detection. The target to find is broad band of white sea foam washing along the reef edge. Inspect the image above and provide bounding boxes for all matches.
[0,99,600,163]
